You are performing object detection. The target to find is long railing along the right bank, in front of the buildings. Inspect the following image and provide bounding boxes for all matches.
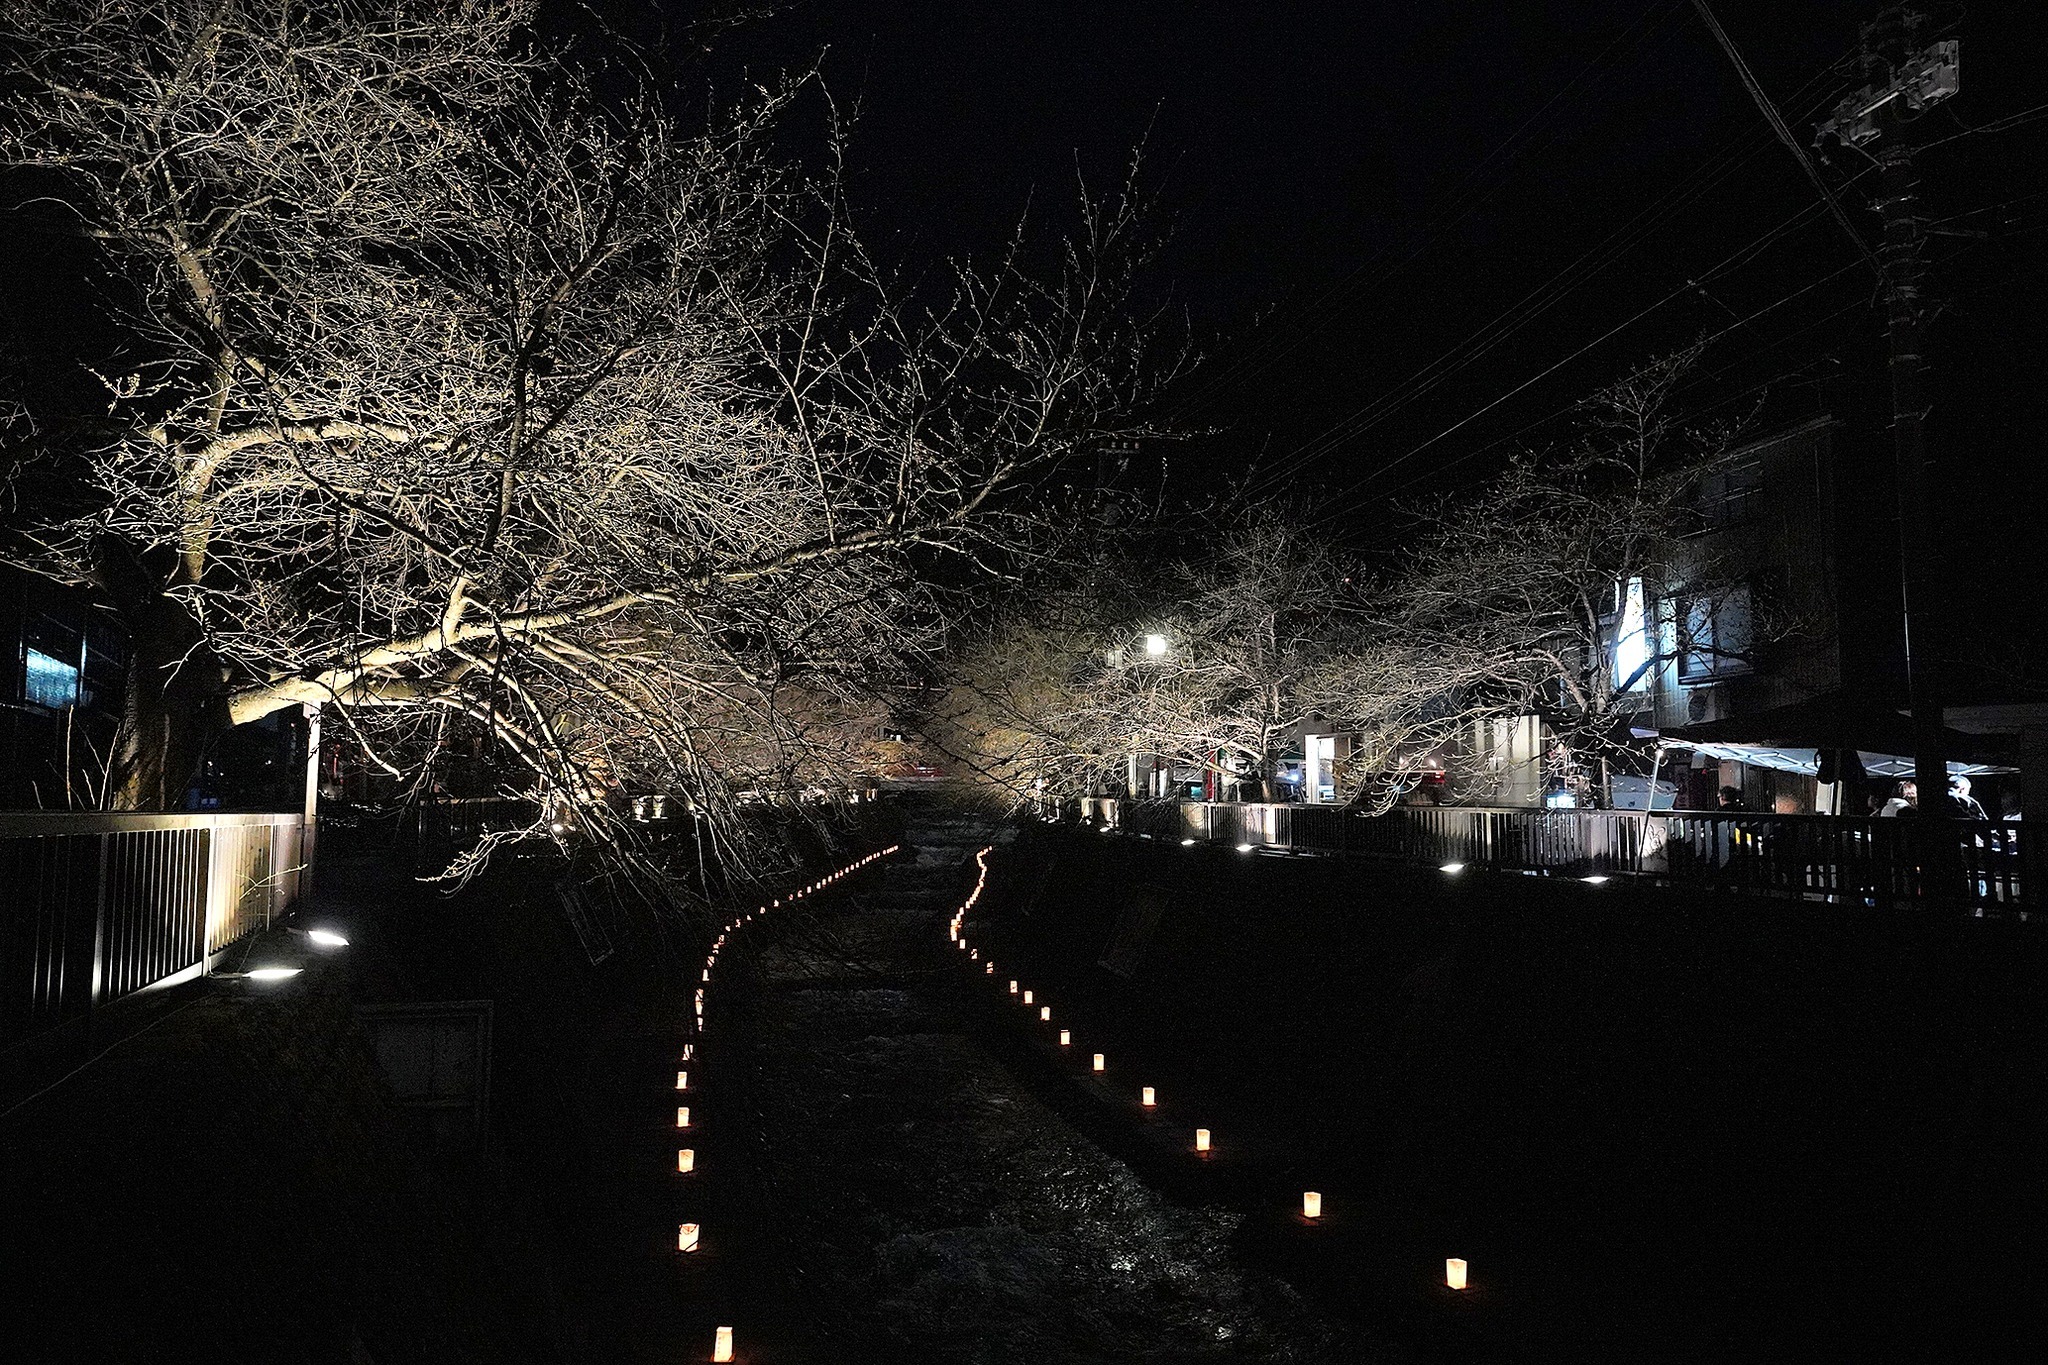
[1073,798,2040,911]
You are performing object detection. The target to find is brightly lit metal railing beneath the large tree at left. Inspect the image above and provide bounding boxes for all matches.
[0,810,309,1052]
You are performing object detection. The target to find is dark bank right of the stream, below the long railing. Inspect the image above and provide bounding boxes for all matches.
[969,831,2048,1361]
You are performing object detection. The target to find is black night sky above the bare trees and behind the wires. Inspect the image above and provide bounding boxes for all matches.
[663,0,2048,654]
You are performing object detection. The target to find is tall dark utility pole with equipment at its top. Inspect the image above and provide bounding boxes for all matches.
[1815,8,1958,818]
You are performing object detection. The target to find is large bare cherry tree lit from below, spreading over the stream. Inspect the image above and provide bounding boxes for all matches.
[0,0,1171,875]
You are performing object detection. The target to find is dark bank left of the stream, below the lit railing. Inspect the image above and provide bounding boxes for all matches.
[0,806,901,1365]
